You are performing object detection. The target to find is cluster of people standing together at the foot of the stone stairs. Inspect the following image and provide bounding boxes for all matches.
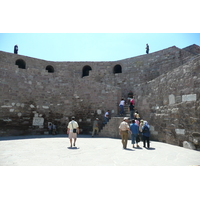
[119,117,150,149]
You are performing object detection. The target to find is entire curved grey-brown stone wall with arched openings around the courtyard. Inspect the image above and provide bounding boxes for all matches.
[0,45,200,149]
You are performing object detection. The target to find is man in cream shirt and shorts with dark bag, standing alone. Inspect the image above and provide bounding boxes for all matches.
[67,117,80,147]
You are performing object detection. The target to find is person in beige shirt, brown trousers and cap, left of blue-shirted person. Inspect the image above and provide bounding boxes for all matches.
[119,117,130,149]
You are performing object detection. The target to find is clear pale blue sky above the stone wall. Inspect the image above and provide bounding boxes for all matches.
[0,33,200,61]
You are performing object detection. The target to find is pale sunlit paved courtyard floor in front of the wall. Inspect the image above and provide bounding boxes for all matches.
[0,135,200,166]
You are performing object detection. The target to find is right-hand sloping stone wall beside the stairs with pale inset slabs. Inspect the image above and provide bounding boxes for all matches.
[134,56,200,147]
